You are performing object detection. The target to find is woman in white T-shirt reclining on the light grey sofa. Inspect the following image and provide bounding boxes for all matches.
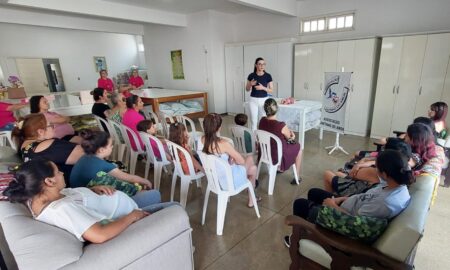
[3,159,173,243]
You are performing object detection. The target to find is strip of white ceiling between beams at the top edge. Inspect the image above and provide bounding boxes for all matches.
[103,0,255,14]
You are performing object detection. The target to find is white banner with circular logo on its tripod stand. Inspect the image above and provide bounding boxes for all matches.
[321,71,351,155]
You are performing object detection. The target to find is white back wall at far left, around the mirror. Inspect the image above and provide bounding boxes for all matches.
[0,23,141,91]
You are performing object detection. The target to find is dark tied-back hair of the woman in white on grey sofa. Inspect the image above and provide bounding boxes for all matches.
[3,159,56,203]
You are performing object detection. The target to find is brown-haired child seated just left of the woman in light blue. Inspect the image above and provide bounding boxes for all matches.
[169,122,204,174]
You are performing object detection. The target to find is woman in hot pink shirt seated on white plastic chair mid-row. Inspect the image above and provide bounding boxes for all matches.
[122,95,145,150]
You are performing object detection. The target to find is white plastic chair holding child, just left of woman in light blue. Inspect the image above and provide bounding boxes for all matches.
[167,141,205,208]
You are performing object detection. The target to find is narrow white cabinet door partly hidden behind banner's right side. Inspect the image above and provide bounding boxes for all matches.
[337,40,355,132]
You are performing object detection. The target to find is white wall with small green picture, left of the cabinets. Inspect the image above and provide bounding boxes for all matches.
[144,11,233,112]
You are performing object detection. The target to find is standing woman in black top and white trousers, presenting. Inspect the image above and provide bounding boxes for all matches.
[245,57,273,130]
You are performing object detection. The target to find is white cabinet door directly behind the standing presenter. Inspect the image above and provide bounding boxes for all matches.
[244,43,278,101]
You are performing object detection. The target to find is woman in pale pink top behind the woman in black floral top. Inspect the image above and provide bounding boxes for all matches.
[30,96,81,143]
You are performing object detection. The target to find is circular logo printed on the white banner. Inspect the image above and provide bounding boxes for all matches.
[323,75,350,113]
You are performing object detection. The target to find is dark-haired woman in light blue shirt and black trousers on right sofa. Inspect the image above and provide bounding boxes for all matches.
[284,150,414,246]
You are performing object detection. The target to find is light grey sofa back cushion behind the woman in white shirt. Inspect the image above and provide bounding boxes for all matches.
[0,202,83,269]
